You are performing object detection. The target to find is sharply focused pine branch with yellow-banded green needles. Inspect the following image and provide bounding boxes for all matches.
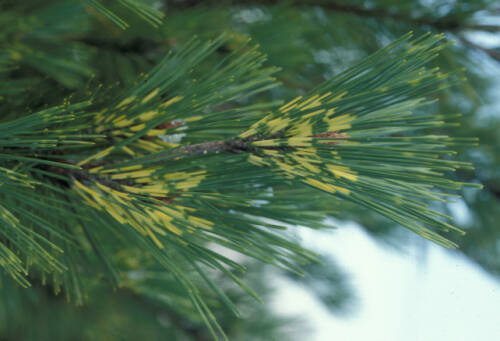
[0,33,482,337]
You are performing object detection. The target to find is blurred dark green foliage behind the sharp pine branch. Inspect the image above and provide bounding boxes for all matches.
[0,0,500,340]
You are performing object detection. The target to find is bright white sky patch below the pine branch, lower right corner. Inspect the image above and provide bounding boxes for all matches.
[273,223,500,341]
